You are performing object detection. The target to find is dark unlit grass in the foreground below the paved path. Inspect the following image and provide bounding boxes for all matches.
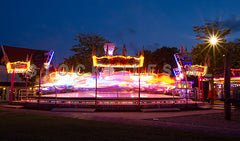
[0,113,239,141]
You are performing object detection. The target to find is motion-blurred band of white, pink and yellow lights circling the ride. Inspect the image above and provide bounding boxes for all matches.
[42,71,175,93]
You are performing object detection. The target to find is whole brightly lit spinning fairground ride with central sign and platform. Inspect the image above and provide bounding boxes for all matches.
[14,43,201,110]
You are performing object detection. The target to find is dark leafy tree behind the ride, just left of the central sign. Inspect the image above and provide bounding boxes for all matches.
[64,33,109,72]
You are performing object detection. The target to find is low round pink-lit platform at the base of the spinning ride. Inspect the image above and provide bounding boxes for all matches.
[18,88,200,106]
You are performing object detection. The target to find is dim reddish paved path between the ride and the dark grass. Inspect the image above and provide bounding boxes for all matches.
[0,105,240,137]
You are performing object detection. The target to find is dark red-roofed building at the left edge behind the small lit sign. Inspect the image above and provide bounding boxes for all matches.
[0,45,54,101]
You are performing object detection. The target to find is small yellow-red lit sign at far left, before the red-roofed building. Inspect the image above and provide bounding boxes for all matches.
[7,61,30,73]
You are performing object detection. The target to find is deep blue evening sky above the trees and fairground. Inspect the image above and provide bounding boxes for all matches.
[0,0,240,64]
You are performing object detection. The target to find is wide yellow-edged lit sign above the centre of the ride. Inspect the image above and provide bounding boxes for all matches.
[93,56,144,68]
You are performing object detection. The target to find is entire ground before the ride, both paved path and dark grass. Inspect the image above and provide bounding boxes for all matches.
[0,102,240,141]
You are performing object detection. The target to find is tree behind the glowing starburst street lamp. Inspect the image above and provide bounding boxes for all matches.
[191,22,239,104]
